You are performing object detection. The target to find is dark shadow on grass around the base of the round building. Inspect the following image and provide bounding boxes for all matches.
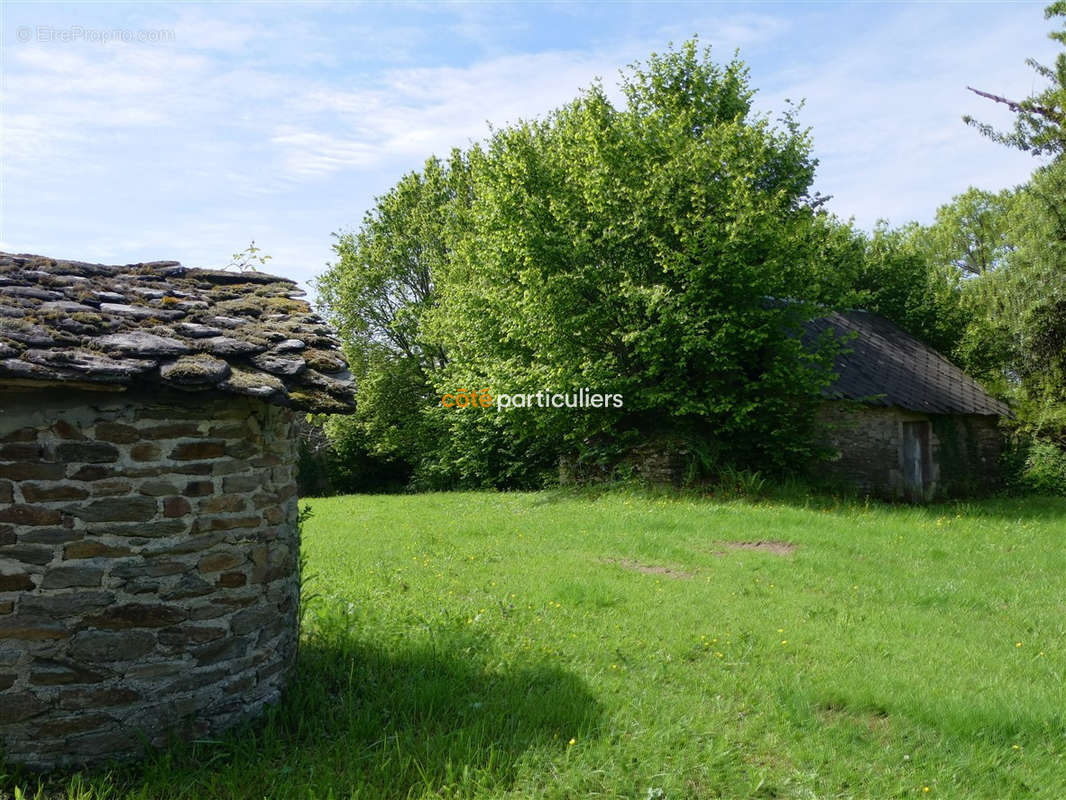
[12,624,602,800]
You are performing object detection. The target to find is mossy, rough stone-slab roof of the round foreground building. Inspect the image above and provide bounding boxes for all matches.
[0,253,354,413]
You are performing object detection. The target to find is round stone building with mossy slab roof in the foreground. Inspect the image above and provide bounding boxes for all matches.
[0,254,353,768]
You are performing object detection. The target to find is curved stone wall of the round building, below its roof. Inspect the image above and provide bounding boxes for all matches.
[0,389,300,768]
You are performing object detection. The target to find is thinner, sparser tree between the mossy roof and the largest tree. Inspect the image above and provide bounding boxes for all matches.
[318,151,468,486]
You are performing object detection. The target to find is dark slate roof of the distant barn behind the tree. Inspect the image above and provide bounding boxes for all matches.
[804,311,1011,416]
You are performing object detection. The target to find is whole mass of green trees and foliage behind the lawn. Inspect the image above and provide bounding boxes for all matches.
[319,36,1066,489]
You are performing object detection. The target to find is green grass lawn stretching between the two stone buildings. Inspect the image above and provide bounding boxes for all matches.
[5,491,1066,800]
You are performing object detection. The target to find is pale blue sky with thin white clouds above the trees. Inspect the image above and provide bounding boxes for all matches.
[0,2,1055,292]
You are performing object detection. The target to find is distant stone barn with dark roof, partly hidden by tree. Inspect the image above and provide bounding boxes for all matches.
[806,311,1010,500]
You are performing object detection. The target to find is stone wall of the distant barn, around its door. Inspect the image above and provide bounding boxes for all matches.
[818,402,1001,499]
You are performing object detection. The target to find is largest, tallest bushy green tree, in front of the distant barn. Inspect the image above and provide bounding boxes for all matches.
[429,42,829,480]
